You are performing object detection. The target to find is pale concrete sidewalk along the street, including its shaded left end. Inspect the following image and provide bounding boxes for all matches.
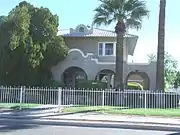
[0,108,180,127]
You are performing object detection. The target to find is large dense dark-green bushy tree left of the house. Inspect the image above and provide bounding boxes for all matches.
[0,1,68,85]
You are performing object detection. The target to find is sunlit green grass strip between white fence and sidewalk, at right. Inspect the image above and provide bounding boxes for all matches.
[62,106,180,117]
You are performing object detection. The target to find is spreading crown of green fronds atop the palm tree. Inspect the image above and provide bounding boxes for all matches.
[93,0,149,29]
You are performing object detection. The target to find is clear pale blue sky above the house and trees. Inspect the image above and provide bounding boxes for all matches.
[0,0,180,63]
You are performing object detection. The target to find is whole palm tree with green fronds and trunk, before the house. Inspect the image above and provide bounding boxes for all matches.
[93,0,149,90]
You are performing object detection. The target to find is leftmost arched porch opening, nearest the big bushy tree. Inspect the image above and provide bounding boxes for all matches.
[62,67,87,87]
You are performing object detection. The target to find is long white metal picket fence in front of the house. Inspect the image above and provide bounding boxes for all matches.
[0,86,180,115]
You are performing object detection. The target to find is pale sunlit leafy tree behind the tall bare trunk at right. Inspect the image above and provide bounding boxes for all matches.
[148,52,178,87]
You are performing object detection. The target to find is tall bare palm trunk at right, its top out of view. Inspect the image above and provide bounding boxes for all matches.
[156,0,166,91]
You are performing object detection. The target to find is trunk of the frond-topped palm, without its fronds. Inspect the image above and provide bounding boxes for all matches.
[115,21,125,90]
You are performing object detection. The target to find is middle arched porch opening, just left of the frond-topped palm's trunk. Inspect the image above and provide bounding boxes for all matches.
[95,69,115,88]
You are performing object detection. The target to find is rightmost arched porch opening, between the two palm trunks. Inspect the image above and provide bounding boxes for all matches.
[126,71,150,90]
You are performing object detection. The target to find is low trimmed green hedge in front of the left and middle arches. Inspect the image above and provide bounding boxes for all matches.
[76,80,107,89]
